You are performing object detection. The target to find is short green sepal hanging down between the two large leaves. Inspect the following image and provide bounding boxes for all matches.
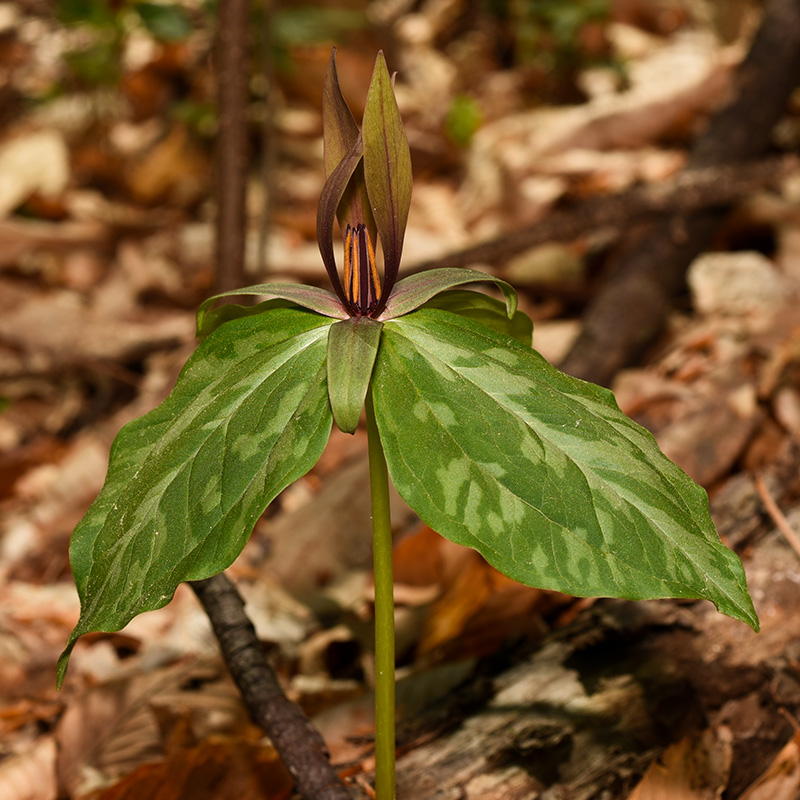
[327,317,383,433]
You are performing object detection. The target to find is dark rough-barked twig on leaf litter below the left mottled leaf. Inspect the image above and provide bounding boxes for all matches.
[190,574,351,800]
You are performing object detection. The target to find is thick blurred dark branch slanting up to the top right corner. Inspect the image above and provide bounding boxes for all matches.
[561,0,800,384]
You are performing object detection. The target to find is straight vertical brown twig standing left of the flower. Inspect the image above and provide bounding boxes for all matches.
[215,0,250,292]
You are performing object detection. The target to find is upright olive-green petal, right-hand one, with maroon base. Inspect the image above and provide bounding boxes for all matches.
[361,53,412,313]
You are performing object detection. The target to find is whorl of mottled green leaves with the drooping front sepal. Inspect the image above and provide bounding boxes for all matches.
[59,287,758,678]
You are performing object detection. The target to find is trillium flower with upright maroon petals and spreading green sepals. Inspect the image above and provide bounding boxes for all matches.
[197,48,516,433]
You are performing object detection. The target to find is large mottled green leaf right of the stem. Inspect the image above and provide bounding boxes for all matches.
[372,309,758,628]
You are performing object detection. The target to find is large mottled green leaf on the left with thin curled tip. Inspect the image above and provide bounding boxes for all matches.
[58,308,332,683]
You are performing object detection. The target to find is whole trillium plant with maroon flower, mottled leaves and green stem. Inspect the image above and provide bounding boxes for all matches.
[58,54,758,800]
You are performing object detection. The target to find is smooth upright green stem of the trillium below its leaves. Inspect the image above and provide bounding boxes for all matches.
[366,392,395,800]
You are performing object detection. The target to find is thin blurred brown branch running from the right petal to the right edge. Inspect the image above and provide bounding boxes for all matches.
[405,157,796,274]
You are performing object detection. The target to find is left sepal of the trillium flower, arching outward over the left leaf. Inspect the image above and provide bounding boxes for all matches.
[195,283,347,339]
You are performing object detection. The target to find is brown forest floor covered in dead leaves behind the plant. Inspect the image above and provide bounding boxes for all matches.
[0,0,800,800]
